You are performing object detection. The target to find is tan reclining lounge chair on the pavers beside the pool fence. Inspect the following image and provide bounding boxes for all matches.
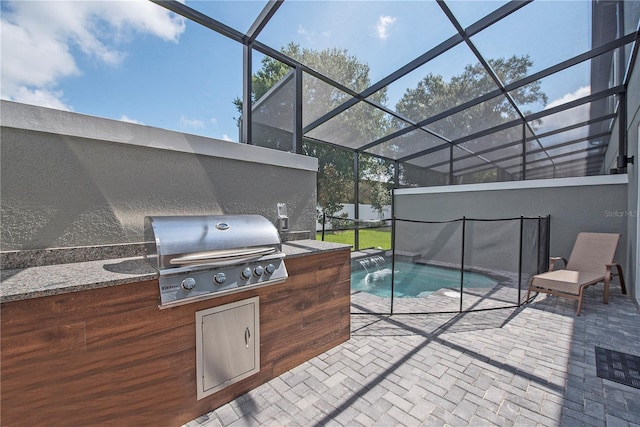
[527,233,627,316]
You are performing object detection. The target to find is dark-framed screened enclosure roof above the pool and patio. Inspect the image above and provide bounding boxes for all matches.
[156,0,640,180]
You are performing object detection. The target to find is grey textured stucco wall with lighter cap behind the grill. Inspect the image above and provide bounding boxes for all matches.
[0,101,317,250]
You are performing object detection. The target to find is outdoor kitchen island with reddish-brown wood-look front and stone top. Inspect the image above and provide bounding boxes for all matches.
[0,240,350,426]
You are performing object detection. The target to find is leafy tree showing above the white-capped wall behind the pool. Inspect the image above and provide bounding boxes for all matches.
[395,55,547,186]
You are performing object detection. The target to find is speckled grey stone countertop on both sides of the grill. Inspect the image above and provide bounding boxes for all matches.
[0,240,350,303]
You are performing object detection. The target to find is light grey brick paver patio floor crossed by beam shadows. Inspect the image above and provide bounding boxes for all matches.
[186,285,640,427]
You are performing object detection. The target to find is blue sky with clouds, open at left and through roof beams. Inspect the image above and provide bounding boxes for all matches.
[0,0,608,141]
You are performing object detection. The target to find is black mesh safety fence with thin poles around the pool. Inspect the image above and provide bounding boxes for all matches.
[351,216,550,314]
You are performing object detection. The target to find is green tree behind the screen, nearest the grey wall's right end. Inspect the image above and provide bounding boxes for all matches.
[234,43,388,222]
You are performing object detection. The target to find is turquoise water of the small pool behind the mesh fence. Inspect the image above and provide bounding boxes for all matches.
[351,262,498,298]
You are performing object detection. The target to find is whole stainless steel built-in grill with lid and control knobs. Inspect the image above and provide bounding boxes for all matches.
[145,215,288,308]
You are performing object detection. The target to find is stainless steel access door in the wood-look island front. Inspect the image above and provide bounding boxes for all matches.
[196,297,260,400]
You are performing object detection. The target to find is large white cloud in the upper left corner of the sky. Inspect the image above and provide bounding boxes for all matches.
[0,0,185,109]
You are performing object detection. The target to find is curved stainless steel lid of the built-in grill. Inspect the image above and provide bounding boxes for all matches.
[149,215,281,270]
